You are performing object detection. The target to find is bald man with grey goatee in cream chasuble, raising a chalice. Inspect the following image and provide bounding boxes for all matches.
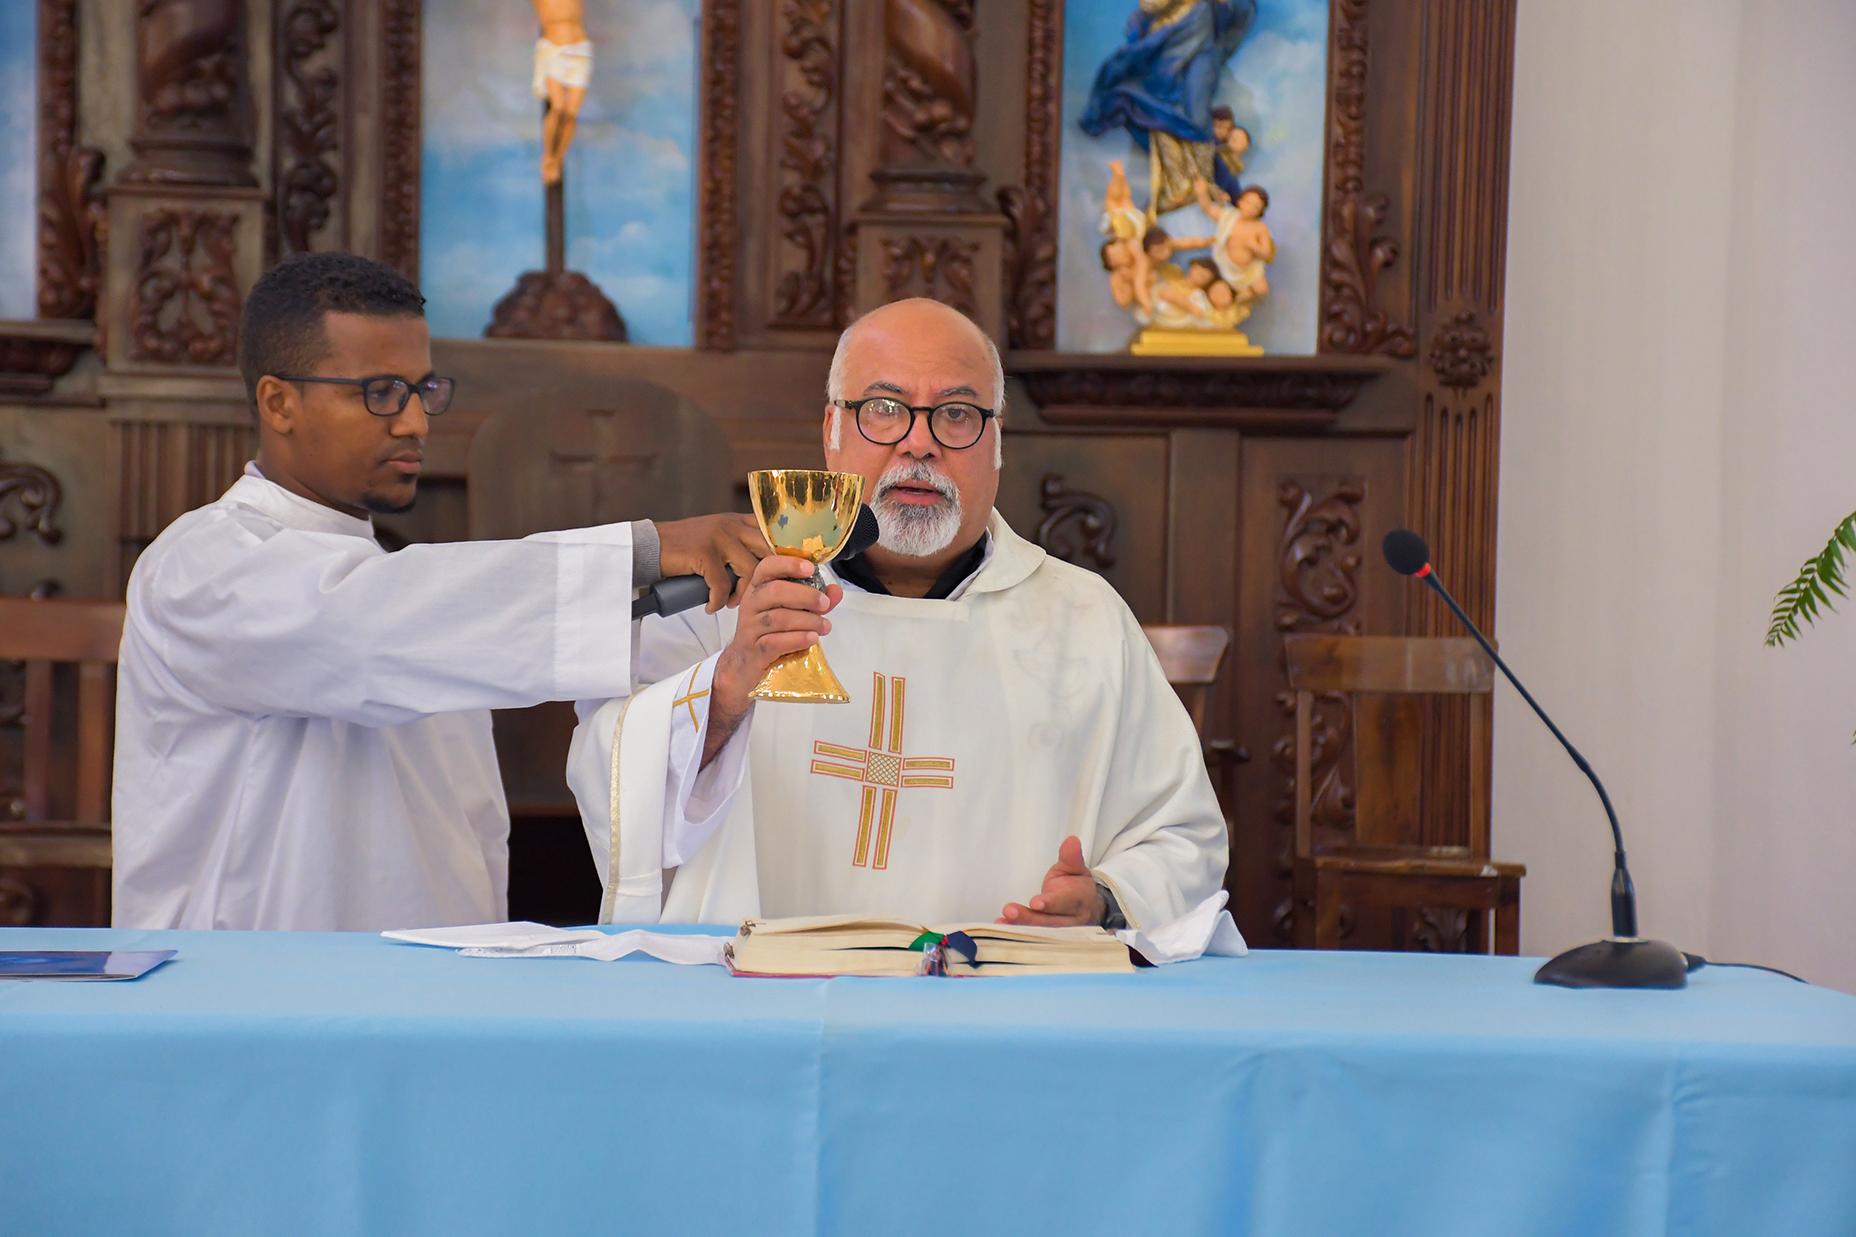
[568,301,1227,927]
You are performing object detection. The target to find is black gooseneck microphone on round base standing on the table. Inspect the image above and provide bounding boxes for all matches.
[1381,527,1689,988]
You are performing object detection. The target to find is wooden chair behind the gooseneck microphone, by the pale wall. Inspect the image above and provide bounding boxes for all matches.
[1282,635,1527,955]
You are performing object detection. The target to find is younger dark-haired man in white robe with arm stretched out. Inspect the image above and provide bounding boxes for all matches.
[113,254,765,931]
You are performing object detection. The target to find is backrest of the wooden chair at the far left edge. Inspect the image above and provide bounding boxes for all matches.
[0,598,124,832]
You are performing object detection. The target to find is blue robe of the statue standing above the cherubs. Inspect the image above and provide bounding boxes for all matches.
[1078,0,1257,150]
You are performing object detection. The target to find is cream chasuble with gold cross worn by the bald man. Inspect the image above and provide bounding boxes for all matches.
[568,511,1227,927]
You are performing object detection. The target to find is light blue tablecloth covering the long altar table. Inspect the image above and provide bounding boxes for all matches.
[0,929,1856,1237]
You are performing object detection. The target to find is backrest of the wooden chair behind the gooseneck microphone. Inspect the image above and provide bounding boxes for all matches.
[1282,635,1496,860]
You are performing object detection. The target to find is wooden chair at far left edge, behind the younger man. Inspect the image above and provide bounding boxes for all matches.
[0,598,124,925]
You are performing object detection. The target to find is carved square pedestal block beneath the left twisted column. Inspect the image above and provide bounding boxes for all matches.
[130,208,241,366]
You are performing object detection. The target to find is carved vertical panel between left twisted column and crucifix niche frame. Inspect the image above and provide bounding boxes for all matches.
[277,0,342,253]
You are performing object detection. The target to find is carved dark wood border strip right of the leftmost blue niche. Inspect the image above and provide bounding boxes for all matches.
[39,0,104,318]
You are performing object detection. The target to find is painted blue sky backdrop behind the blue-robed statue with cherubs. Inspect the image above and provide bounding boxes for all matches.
[1056,0,1327,353]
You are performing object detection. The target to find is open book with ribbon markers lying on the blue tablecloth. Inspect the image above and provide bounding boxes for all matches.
[724,916,1134,975]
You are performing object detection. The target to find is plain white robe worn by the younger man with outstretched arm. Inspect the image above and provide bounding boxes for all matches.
[113,470,638,931]
